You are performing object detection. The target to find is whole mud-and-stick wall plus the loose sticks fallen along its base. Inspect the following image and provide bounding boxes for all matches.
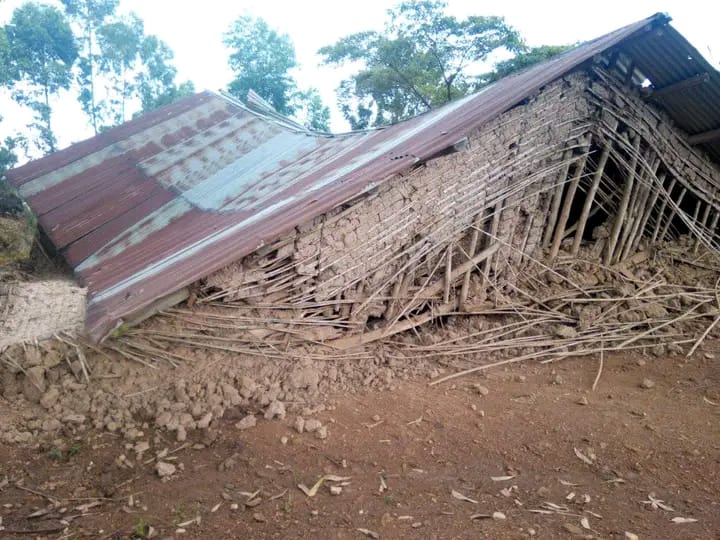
[112,62,720,368]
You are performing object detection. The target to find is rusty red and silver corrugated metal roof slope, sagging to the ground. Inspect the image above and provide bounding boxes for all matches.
[7,15,716,339]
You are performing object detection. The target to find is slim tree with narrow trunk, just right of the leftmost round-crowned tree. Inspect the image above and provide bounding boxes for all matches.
[61,0,120,133]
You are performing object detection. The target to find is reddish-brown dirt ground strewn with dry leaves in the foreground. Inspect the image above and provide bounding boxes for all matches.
[0,344,720,539]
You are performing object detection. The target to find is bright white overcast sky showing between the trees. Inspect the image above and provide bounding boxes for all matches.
[0,0,720,159]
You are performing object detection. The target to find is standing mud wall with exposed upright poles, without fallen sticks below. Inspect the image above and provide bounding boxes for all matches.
[200,65,720,346]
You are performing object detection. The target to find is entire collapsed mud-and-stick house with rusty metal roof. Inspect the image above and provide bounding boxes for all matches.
[2,14,720,370]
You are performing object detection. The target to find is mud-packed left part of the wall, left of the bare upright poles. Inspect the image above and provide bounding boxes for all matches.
[206,74,594,328]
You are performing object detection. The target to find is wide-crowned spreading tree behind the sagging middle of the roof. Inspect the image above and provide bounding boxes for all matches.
[318,0,523,129]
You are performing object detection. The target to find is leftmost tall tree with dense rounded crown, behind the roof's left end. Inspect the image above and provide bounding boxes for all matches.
[5,3,77,154]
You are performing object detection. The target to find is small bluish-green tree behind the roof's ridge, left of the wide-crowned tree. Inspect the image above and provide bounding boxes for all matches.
[224,15,330,131]
